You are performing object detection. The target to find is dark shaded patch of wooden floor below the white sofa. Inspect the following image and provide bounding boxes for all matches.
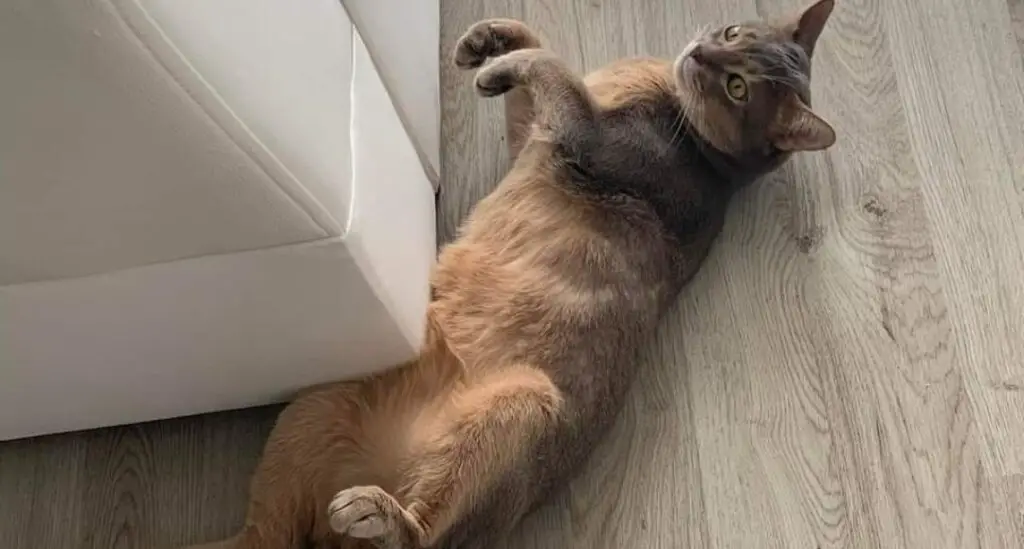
[0,407,279,549]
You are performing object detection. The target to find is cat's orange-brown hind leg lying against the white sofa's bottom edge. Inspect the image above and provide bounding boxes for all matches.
[180,374,407,549]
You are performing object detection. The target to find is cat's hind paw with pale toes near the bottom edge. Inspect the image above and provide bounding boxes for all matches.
[328,487,399,540]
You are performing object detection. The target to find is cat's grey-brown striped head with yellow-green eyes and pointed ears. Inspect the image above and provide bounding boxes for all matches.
[675,0,836,158]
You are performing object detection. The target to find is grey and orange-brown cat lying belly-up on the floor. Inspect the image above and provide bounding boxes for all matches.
[184,0,836,549]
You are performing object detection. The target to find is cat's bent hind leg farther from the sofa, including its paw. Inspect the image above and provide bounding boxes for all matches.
[328,367,562,549]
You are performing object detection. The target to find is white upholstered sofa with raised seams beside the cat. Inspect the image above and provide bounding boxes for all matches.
[0,0,439,439]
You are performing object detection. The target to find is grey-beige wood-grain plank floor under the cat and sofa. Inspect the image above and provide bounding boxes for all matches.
[0,0,1024,549]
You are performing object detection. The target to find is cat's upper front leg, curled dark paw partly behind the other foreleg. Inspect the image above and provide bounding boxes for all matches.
[452,18,541,161]
